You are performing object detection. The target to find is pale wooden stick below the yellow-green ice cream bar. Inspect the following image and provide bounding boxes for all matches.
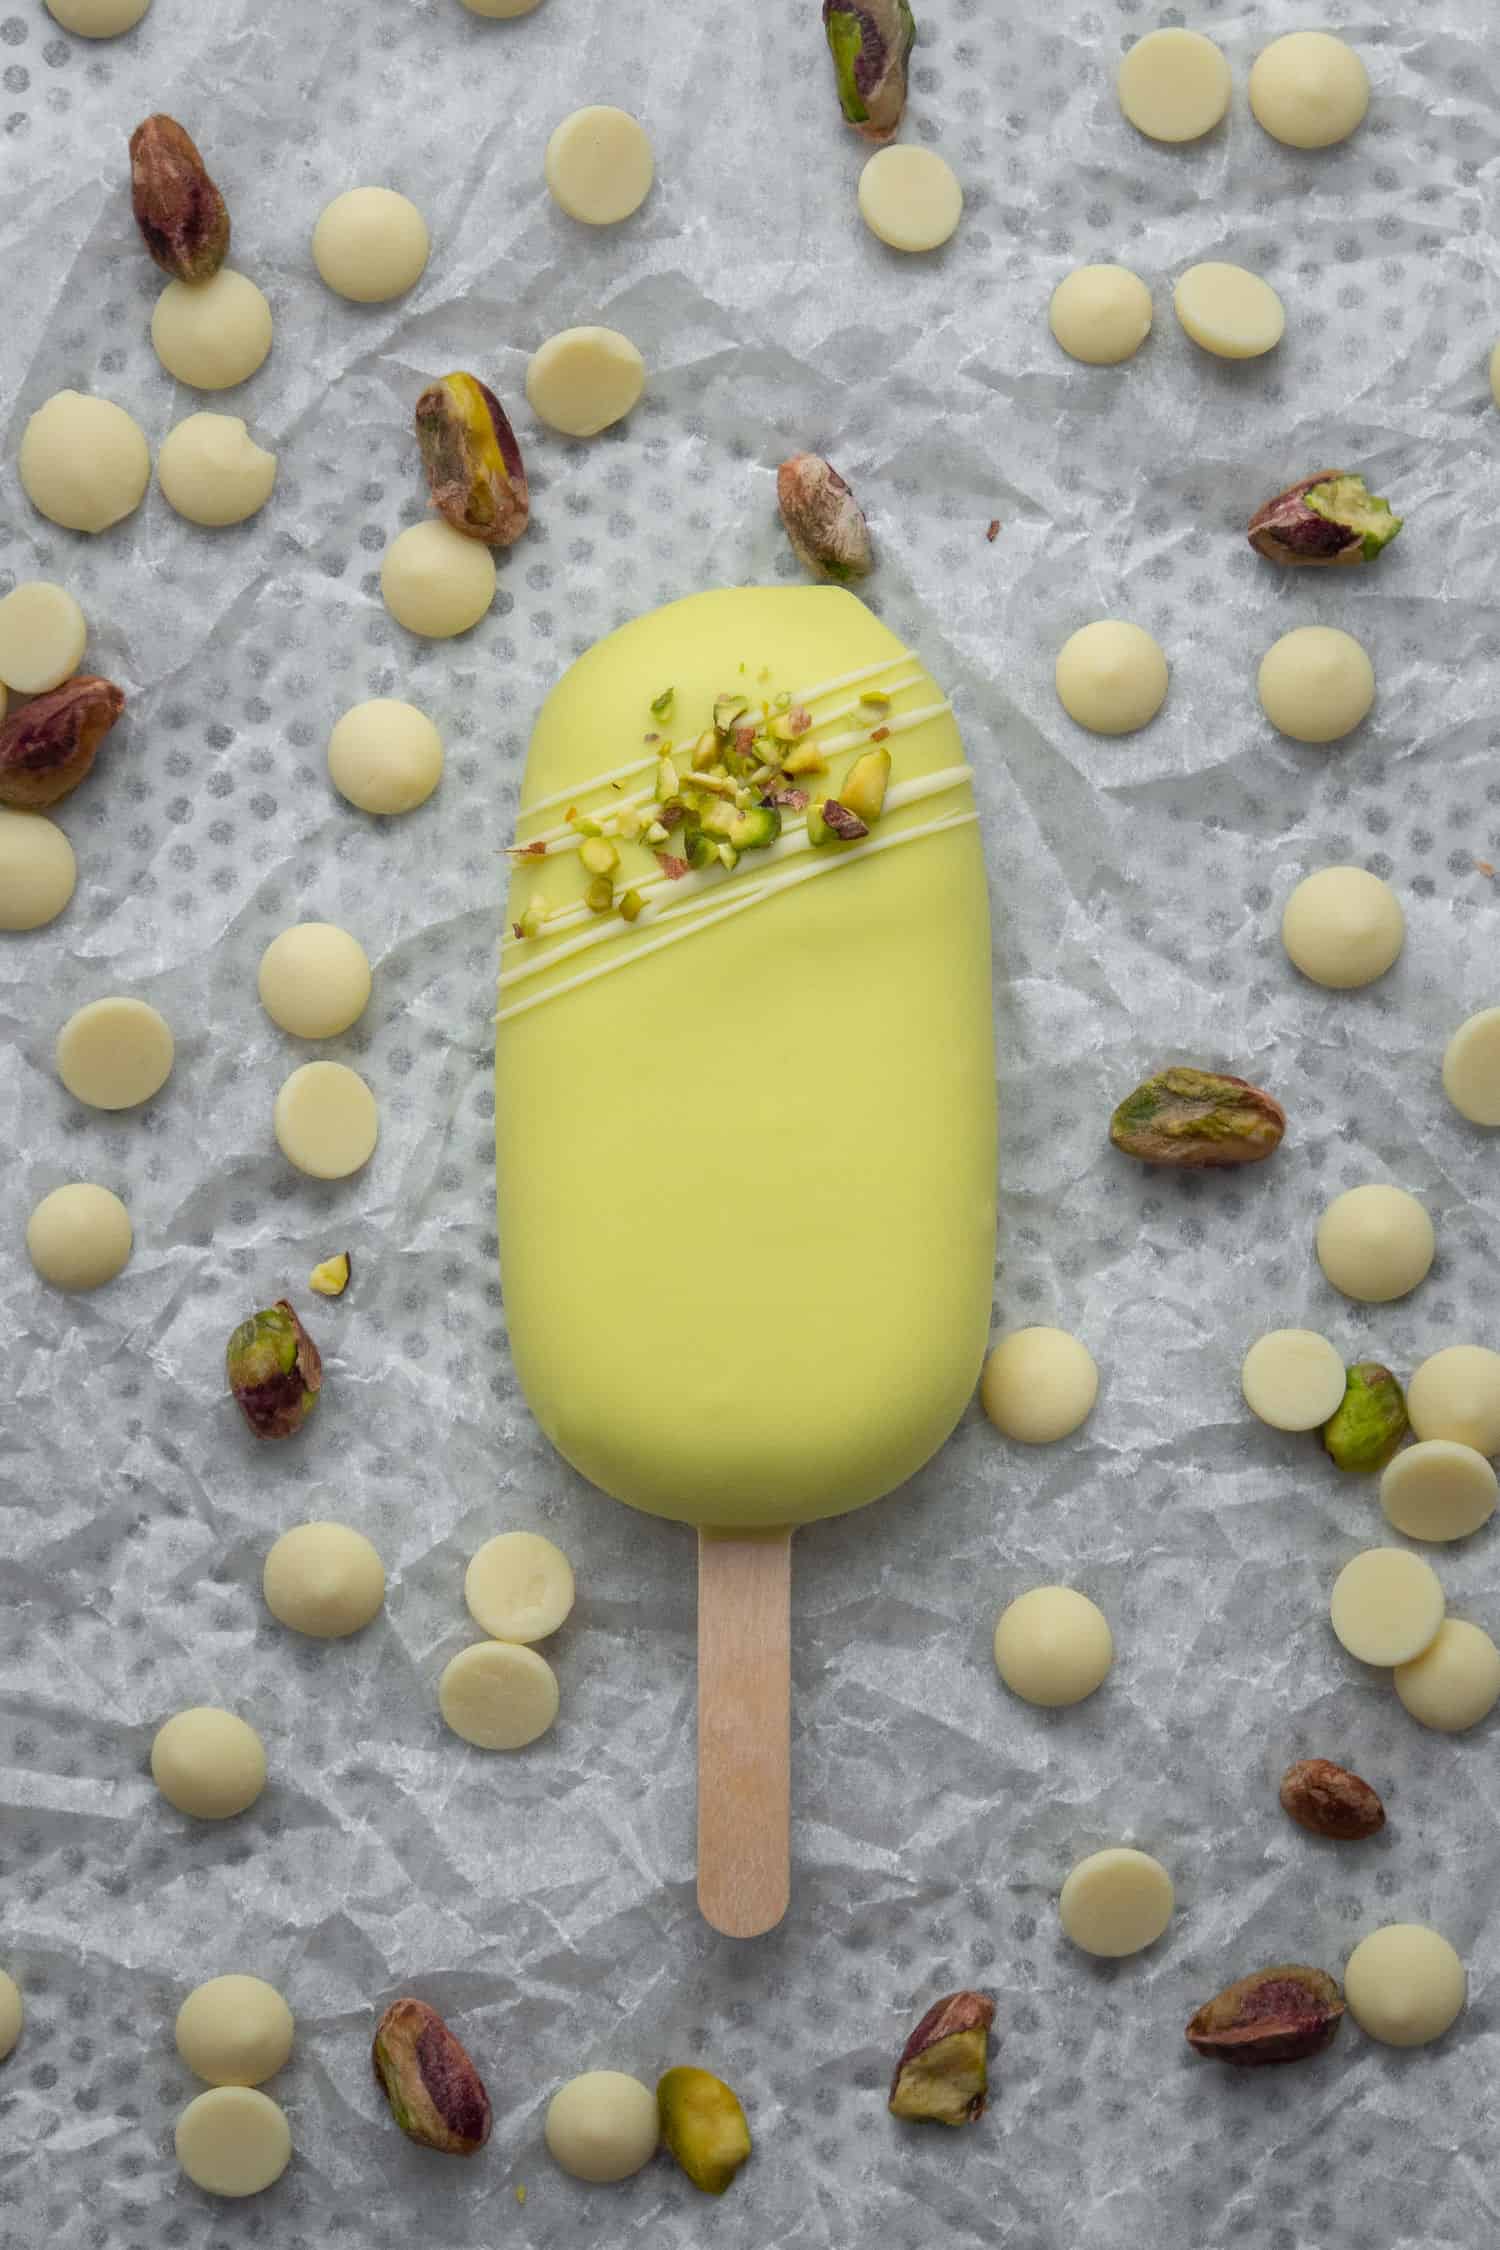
[697,1530,792,1937]
